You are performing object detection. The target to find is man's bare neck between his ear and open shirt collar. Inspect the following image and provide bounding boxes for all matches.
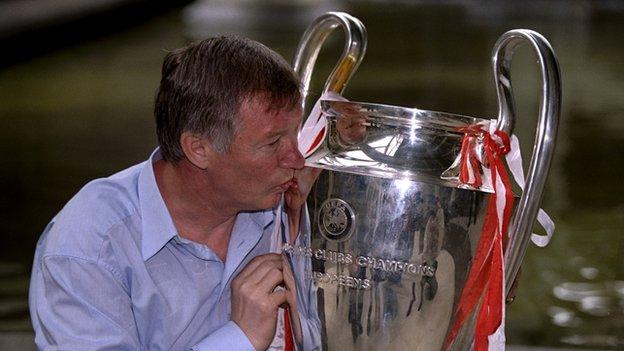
[154,160,238,262]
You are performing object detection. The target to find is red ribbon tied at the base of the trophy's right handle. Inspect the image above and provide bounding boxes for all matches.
[444,125,513,351]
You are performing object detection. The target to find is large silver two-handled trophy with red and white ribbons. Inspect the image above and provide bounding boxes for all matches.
[282,13,560,351]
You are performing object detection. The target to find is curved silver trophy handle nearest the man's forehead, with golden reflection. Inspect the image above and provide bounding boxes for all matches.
[292,12,366,115]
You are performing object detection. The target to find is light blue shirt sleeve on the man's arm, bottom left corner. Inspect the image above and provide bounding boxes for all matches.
[30,256,142,351]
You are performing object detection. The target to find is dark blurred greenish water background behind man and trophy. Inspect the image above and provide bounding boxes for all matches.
[0,0,624,350]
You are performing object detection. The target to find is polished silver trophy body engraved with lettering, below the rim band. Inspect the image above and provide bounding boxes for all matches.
[304,171,491,350]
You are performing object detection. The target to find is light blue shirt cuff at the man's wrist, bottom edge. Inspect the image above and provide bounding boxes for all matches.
[191,321,256,351]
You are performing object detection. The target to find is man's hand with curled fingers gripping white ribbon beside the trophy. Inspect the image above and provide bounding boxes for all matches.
[231,254,287,350]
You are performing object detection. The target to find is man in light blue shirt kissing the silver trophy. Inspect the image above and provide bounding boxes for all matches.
[30,36,317,350]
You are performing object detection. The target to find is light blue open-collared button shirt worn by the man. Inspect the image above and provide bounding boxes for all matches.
[29,150,320,351]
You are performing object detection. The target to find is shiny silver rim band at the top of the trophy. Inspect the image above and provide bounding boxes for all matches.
[314,100,493,192]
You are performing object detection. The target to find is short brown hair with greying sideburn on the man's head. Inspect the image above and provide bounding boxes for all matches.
[154,35,301,162]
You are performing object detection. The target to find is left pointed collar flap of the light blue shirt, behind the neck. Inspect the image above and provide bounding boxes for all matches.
[138,148,178,261]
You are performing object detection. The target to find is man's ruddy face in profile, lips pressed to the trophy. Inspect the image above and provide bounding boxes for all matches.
[211,96,304,211]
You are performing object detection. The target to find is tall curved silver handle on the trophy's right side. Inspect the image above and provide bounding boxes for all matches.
[492,29,561,300]
